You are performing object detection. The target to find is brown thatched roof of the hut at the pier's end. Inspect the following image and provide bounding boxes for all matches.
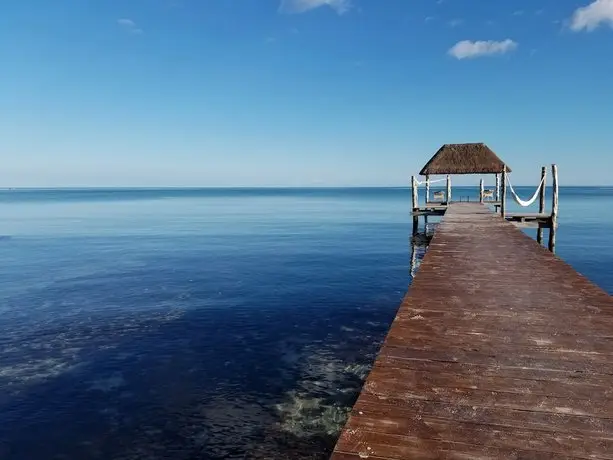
[419,142,511,176]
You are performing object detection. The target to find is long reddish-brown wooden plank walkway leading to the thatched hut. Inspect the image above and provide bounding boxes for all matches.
[332,204,613,460]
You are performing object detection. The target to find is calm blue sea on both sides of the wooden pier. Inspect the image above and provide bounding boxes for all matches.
[0,188,613,460]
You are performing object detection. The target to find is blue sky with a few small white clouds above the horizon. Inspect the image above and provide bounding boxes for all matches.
[0,0,613,186]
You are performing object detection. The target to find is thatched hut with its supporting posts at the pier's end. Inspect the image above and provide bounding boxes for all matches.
[419,142,511,208]
